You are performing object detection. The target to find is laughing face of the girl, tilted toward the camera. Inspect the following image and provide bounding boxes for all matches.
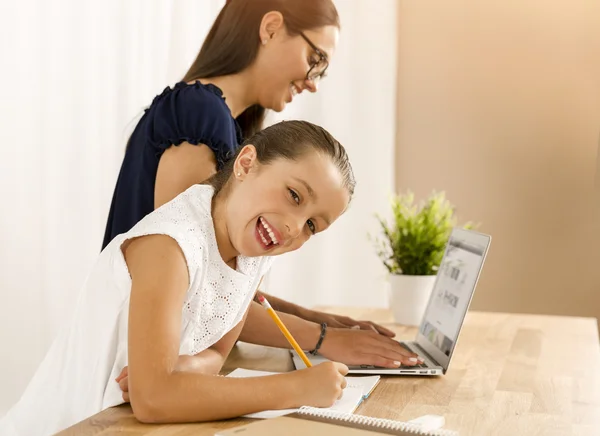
[226,145,350,256]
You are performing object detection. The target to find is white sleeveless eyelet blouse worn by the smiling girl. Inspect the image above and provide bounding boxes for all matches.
[0,185,272,436]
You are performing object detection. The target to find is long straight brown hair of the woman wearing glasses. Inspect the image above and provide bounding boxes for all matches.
[183,0,340,138]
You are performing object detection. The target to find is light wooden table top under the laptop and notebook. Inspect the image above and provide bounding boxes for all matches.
[60,308,600,436]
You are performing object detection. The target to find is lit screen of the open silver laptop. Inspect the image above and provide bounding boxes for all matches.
[419,229,489,366]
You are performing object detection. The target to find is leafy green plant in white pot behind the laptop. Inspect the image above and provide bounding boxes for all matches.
[375,191,472,326]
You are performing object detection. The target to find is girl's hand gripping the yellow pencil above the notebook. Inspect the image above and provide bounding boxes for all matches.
[290,362,348,407]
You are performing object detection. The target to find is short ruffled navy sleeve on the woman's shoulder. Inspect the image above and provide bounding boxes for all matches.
[145,82,240,169]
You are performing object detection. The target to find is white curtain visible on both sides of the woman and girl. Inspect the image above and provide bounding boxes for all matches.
[0,0,396,414]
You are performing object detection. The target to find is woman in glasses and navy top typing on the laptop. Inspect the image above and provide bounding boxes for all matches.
[103,0,417,367]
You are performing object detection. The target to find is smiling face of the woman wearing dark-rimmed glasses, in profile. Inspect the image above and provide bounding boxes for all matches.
[255,20,339,112]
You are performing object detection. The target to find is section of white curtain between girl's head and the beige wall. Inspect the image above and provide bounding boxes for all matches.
[266,0,397,312]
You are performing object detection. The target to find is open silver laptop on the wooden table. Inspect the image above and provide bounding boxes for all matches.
[291,227,492,376]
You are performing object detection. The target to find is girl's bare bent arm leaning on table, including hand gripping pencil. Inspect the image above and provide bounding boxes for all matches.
[123,235,332,422]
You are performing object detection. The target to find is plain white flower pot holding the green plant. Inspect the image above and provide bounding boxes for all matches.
[389,274,436,326]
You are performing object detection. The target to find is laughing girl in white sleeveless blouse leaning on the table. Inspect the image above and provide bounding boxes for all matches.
[0,121,355,436]
